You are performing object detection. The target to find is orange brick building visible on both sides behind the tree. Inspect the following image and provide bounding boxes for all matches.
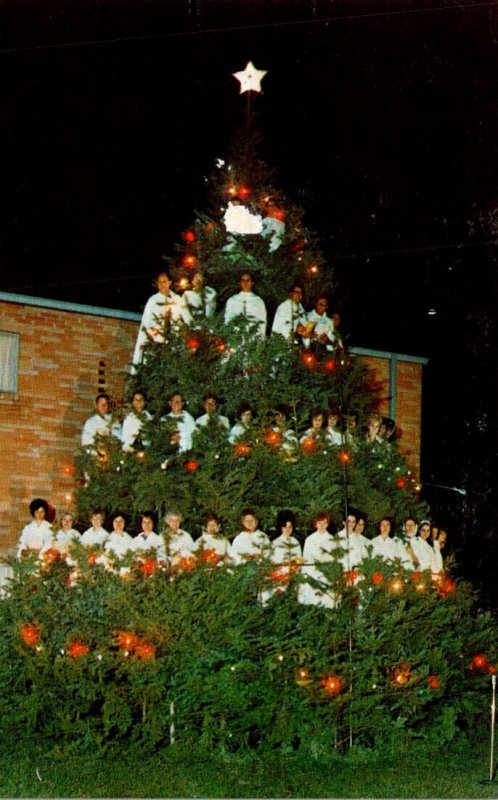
[0,292,425,555]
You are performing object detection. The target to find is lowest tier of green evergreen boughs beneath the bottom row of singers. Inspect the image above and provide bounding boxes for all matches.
[0,549,498,756]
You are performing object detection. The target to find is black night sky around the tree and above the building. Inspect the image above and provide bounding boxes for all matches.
[0,0,498,607]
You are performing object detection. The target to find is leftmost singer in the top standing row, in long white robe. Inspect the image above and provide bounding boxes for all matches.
[132,270,192,366]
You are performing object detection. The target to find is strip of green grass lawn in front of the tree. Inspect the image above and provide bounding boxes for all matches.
[0,738,498,798]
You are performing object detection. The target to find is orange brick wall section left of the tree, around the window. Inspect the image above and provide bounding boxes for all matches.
[0,301,138,554]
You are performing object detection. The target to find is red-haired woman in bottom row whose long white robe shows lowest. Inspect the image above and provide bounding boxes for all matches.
[298,512,340,608]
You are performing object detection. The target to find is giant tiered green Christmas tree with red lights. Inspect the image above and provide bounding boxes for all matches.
[0,65,498,758]
